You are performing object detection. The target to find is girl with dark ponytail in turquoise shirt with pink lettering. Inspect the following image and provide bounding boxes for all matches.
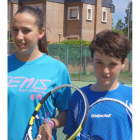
[8,6,70,140]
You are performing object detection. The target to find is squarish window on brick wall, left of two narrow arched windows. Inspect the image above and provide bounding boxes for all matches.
[68,6,79,20]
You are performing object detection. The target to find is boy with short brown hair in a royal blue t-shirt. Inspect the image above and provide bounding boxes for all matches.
[64,30,132,140]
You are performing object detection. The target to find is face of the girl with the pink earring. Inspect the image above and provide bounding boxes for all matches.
[12,12,42,54]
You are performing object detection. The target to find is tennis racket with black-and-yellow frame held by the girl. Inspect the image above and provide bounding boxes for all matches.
[25,84,89,140]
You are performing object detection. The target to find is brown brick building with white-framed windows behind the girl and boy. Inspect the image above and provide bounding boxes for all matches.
[8,0,115,43]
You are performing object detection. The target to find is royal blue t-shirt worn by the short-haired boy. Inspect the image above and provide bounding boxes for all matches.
[63,84,132,140]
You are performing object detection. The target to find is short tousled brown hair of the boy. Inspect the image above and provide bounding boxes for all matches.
[89,30,130,63]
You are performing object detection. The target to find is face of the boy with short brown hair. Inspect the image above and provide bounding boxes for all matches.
[91,51,126,86]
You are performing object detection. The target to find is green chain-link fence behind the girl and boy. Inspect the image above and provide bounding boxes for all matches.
[48,44,132,83]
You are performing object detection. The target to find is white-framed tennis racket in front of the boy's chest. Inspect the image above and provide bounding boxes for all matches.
[78,98,132,140]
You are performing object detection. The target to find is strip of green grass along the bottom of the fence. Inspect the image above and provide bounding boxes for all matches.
[70,72,132,84]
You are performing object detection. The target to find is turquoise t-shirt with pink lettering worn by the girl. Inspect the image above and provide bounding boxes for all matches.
[8,53,70,140]
